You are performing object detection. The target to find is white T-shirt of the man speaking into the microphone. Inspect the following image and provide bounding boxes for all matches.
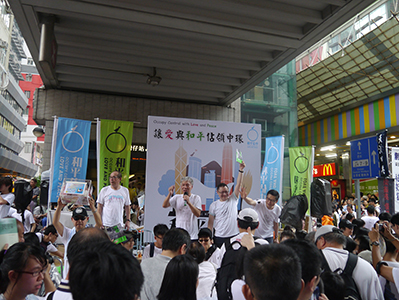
[169,194,201,240]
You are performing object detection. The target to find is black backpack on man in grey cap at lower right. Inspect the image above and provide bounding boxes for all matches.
[320,250,362,300]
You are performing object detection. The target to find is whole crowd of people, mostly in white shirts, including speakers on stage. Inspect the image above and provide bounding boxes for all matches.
[0,169,399,300]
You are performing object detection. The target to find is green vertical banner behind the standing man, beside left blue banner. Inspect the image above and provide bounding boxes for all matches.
[97,119,133,193]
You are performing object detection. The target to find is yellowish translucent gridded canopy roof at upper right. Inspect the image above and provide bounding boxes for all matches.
[297,17,399,123]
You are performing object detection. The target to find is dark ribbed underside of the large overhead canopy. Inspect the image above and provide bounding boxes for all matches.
[8,0,374,105]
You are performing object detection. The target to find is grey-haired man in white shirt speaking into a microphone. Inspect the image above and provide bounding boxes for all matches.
[162,176,201,240]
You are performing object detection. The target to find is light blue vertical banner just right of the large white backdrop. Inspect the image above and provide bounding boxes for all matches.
[260,136,284,205]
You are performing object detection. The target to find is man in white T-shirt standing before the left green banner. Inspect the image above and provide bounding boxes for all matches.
[97,171,130,230]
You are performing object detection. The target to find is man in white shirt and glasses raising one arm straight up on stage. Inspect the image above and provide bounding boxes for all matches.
[208,161,245,247]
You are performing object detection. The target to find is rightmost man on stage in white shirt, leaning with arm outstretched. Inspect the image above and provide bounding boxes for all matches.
[241,188,281,244]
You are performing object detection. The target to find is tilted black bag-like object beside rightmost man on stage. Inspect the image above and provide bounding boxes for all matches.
[280,195,309,230]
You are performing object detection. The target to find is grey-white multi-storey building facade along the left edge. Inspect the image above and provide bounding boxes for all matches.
[0,1,37,178]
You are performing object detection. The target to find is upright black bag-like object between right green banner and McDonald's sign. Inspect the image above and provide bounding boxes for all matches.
[310,178,332,218]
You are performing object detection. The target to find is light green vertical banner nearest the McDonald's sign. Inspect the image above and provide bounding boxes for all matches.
[289,146,314,215]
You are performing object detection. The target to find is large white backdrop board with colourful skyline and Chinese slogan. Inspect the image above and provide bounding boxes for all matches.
[145,116,261,230]
